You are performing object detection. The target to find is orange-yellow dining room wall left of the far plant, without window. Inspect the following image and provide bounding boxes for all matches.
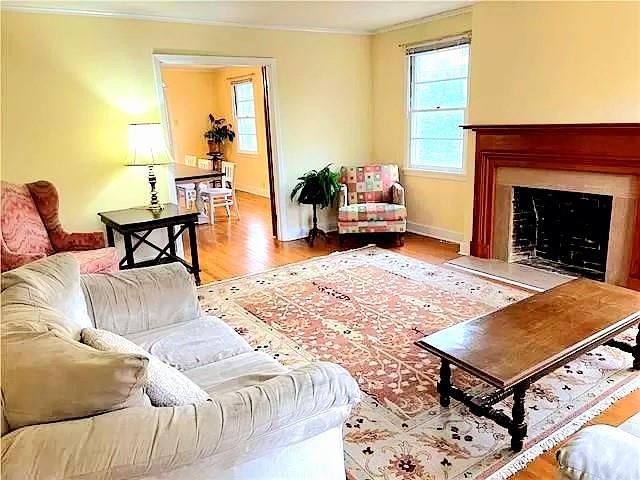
[162,68,218,163]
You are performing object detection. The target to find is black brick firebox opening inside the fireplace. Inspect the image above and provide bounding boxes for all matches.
[510,187,613,281]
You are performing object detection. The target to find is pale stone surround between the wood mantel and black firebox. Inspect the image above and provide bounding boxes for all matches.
[493,167,640,285]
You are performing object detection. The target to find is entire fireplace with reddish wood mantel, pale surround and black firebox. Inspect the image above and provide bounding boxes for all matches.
[464,123,640,289]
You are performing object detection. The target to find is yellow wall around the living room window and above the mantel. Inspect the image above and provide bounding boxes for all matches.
[372,2,640,248]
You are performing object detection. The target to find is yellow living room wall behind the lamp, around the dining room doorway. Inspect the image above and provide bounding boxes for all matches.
[2,11,371,238]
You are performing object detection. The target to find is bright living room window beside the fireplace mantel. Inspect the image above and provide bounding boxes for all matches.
[407,39,469,173]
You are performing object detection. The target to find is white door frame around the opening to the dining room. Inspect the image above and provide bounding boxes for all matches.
[152,53,288,240]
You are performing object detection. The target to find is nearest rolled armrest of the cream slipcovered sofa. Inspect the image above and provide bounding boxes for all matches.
[2,362,360,480]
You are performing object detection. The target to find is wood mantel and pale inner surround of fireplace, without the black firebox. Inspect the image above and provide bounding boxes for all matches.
[463,123,640,290]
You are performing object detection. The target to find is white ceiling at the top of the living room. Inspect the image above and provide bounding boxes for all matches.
[2,0,471,33]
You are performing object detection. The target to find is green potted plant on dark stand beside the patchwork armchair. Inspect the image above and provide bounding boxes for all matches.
[291,164,340,247]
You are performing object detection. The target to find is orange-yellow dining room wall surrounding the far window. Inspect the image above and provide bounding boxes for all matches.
[211,67,269,197]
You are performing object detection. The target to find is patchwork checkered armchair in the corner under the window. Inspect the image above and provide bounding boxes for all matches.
[338,165,407,245]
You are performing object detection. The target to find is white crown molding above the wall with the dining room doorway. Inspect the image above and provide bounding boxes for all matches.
[0,2,376,36]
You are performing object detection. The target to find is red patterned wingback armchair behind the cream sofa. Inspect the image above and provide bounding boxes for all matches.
[0,181,118,273]
